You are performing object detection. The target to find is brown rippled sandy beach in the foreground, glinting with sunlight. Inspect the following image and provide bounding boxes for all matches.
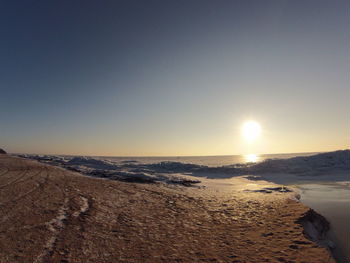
[0,155,334,263]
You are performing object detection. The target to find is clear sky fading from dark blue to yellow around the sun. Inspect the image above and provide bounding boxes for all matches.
[0,0,350,156]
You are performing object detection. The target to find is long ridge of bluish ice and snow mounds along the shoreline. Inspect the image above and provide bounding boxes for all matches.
[20,150,350,185]
